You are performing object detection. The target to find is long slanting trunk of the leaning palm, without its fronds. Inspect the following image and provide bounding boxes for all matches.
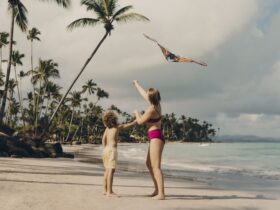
[41,32,109,137]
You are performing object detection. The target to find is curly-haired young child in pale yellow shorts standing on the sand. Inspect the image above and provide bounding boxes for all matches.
[102,111,136,196]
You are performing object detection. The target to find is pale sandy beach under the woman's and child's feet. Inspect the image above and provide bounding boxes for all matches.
[0,146,280,210]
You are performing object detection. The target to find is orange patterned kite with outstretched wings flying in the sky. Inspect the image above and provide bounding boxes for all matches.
[143,34,207,66]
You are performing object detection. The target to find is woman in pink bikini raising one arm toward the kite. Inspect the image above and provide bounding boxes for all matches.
[133,80,165,200]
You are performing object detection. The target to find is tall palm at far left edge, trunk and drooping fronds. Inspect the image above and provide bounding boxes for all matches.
[0,0,28,124]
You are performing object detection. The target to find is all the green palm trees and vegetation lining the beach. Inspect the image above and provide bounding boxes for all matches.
[0,0,216,146]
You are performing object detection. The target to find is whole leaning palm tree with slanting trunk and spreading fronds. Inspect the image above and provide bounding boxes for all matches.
[45,0,149,135]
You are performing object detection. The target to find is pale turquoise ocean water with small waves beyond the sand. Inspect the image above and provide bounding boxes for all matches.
[70,142,280,196]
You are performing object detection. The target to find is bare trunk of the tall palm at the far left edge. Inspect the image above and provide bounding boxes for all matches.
[0,9,15,125]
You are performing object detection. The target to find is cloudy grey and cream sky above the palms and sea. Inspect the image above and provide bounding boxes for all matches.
[0,0,280,138]
